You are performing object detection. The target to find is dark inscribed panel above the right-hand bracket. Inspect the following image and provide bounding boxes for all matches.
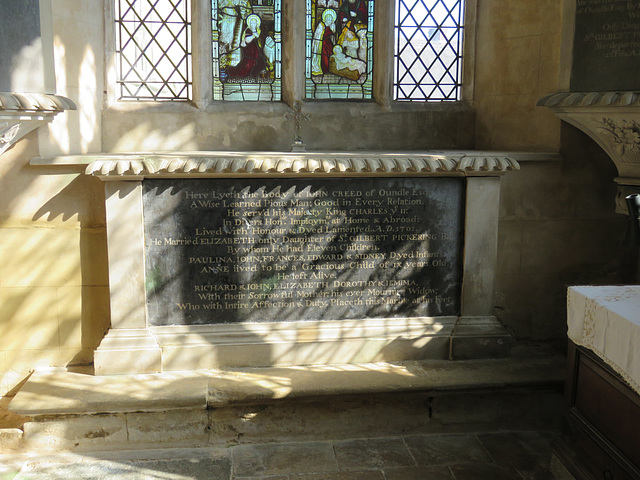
[571,0,640,92]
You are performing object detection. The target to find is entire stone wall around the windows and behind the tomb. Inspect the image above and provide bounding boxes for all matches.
[0,0,624,393]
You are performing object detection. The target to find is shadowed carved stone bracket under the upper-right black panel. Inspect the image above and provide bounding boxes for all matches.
[538,92,640,214]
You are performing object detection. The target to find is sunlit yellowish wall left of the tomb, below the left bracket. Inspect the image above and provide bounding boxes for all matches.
[0,132,109,394]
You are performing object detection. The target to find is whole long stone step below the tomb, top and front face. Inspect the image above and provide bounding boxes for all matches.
[0,344,564,451]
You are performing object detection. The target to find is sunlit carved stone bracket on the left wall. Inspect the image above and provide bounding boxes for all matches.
[0,92,76,155]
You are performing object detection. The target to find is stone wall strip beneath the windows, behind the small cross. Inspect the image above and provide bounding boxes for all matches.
[103,103,473,153]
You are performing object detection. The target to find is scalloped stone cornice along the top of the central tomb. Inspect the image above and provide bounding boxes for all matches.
[32,152,520,180]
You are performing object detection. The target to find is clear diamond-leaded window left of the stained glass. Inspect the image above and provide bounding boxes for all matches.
[116,0,191,100]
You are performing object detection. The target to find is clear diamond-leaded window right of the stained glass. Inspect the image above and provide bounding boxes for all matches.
[394,0,464,102]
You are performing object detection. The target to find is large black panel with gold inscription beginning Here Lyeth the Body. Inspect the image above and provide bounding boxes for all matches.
[144,178,465,325]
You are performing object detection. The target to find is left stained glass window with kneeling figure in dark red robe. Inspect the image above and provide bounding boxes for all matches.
[211,0,282,101]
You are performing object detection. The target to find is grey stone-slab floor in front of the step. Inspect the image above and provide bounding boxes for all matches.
[0,431,555,480]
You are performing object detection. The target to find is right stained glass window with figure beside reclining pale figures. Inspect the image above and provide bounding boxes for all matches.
[306,0,374,99]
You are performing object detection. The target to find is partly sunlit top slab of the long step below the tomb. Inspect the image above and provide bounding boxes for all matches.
[8,344,564,418]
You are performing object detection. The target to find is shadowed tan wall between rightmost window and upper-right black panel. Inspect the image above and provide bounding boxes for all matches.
[474,0,563,151]
